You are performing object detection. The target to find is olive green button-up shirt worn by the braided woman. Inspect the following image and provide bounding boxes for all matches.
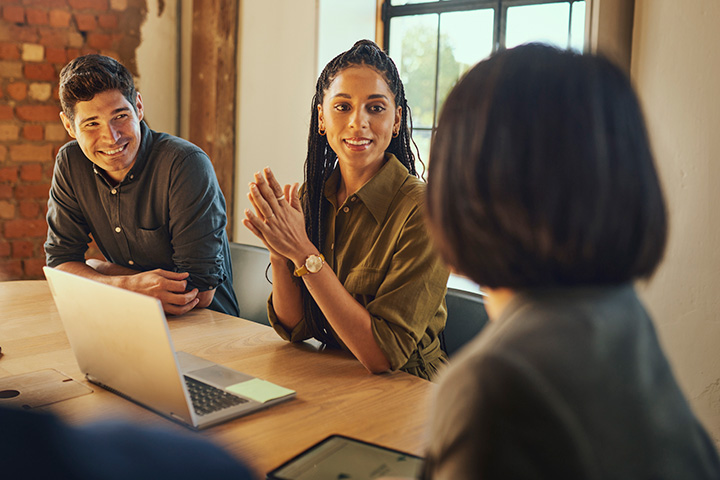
[268,155,449,379]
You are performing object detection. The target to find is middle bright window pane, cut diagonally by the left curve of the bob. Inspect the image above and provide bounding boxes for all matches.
[435,9,495,122]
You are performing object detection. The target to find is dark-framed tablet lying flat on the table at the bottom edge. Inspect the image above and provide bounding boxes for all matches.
[267,435,422,480]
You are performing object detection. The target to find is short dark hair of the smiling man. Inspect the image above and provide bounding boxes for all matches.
[59,54,137,122]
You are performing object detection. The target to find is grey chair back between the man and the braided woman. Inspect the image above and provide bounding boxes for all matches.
[230,242,272,325]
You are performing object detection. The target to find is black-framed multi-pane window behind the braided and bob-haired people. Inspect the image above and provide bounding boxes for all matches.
[382,0,585,165]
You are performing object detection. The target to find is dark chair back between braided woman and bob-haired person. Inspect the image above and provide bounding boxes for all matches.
[440,288,488,357]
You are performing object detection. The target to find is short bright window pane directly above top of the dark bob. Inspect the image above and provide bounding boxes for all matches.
[505,2,570,48]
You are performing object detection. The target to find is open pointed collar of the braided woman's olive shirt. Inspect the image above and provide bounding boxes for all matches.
[324,153,410,223]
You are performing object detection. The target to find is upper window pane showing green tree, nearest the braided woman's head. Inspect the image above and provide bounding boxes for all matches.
[389,13,438,128]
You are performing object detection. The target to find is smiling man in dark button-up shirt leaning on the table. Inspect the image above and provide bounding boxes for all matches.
[45,55,239,316]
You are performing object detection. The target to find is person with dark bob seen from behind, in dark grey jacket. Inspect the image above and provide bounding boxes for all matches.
[424,44,720,480]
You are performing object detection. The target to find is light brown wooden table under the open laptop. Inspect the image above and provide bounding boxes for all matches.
[0,280,434,478]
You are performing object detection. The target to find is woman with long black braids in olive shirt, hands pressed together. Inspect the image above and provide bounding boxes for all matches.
[243,40,448,379]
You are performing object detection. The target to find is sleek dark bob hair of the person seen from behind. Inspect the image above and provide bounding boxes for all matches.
[427,44,667,289]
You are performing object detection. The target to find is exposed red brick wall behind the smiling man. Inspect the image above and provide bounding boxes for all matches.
[0,0,147,280]
